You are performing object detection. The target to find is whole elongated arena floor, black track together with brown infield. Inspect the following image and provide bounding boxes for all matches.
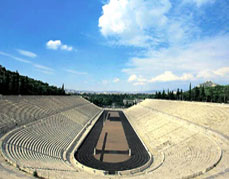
[74,110,150,174]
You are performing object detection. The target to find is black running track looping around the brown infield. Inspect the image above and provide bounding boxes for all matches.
[75,111,150,174]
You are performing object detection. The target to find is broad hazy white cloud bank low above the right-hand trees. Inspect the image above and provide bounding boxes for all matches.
[122,35,229,85]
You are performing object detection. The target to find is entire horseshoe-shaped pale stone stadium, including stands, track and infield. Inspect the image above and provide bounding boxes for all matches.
[0,96,229,179]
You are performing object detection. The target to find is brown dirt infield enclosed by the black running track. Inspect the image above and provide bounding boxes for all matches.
[95,112,130,163]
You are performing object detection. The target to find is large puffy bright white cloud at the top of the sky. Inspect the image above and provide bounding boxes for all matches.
[98,0,174,47]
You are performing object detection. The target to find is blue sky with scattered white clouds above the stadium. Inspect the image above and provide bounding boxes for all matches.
[0,0,229,92]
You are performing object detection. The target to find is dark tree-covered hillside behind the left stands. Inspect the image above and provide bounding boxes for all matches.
[0,65,65,95]
